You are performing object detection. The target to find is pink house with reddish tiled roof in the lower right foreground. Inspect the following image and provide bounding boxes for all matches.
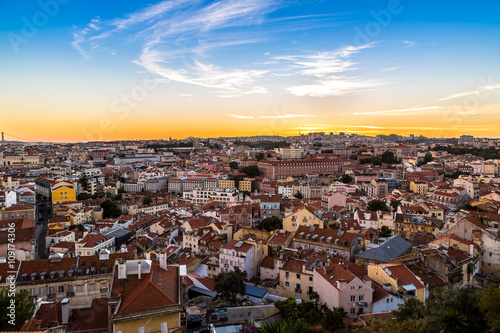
[313,264,373,318]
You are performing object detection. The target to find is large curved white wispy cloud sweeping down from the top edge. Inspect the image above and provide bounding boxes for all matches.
[72,0,286,96]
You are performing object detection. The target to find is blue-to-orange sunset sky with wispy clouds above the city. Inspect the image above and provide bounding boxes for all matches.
[0,0,500,142]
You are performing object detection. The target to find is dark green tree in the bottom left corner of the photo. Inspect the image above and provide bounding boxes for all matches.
[0,288,35,331]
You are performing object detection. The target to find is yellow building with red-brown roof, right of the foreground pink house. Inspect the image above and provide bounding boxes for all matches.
[368,264,427,302]
